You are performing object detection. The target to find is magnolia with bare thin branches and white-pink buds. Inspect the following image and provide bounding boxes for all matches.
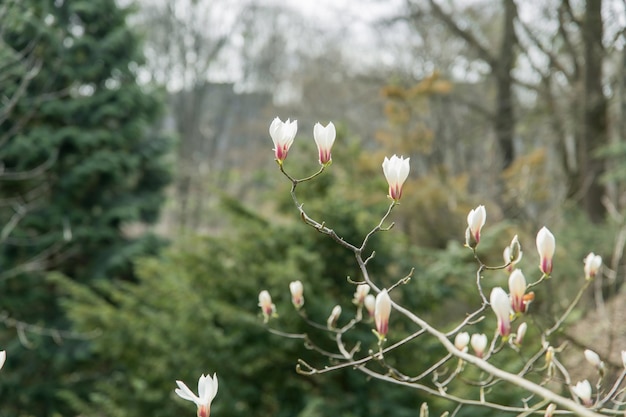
[176,114,626,417]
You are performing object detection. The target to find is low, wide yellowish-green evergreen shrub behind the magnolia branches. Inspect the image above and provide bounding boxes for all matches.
[54,190,446,417]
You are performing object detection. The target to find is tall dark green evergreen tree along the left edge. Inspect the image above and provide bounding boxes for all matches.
[0,0,170,417]
